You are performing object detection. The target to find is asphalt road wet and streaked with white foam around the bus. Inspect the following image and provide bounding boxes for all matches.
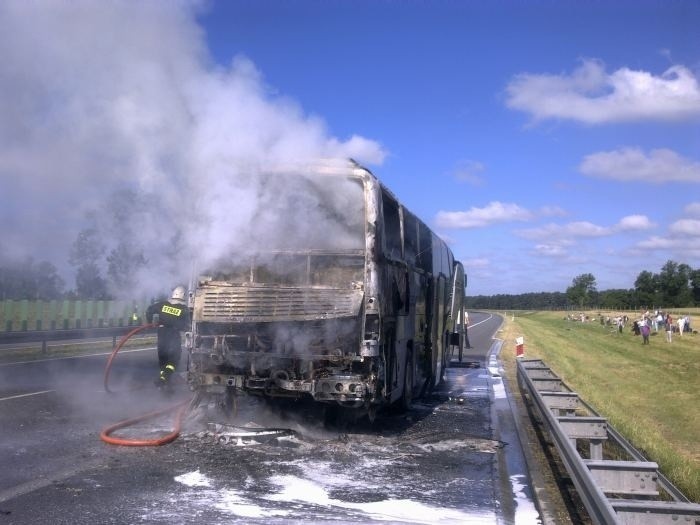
[0,312,537,525]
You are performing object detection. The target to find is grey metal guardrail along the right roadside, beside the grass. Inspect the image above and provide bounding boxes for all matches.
[517,359,700,525]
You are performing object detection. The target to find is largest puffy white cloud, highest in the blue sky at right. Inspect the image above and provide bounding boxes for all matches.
[506,59,700,124]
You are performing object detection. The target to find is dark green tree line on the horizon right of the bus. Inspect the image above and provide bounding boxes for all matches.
[466,260,700,310]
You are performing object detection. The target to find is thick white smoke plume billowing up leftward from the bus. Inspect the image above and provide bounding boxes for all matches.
[0,0,385,296]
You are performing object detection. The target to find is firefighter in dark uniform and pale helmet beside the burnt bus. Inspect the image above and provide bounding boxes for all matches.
[146,286,191,387]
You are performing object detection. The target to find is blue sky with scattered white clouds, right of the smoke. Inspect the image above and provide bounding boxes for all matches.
[201,1,700,294]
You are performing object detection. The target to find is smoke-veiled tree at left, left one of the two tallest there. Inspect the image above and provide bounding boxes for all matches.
[69,227,110,299]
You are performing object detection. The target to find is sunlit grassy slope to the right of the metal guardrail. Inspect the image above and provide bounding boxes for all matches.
[500,310,700,502]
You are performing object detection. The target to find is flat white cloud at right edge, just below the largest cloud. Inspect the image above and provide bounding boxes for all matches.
[579,148,700,184]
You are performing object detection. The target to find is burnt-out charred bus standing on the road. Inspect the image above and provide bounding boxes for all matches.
[188,162,466,413]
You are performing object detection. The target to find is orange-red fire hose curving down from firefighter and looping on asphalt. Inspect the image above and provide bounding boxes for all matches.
[100,323,190,447]
